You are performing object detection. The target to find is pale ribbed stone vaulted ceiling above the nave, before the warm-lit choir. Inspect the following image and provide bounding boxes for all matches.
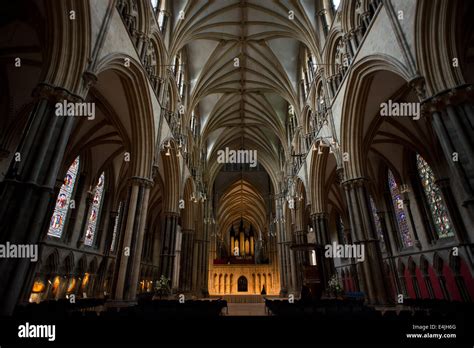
[169,0,319,184]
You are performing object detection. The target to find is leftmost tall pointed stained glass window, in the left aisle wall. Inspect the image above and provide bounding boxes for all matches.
[48,157,79,238]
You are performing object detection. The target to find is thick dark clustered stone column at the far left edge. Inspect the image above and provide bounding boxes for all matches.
[0,84,82,315]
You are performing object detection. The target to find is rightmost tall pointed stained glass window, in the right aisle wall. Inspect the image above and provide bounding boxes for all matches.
[416,154,454,238]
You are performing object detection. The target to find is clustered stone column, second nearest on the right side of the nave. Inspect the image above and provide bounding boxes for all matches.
[343,178,388,304]
